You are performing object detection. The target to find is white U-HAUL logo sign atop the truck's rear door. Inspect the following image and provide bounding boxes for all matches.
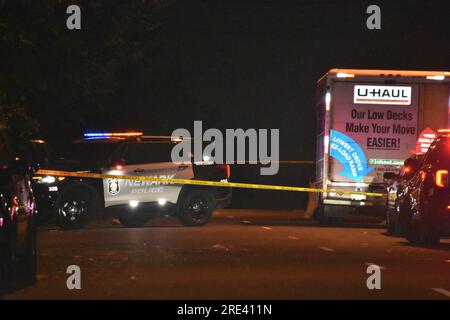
[353,85,411,105]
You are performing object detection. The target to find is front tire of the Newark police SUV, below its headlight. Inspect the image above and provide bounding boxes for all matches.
[56,187,96,230]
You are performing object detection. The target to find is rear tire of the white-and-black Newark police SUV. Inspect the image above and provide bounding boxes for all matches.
[178,189,214,227]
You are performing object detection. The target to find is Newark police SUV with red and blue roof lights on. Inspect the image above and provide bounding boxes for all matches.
[37,132,231,229]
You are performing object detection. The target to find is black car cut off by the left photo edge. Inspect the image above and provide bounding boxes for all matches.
[0,127,37,293]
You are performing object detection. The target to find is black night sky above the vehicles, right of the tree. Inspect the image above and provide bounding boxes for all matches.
[0,0,450,159]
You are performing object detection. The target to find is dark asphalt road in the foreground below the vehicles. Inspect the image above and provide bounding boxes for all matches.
[6,210,450,299]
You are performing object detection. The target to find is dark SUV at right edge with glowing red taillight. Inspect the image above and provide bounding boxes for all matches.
[399,134,450,244]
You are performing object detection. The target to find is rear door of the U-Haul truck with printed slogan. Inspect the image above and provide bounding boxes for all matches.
[330,81,418,183]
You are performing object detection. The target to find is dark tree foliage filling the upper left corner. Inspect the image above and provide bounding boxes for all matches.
[0,0,173,139]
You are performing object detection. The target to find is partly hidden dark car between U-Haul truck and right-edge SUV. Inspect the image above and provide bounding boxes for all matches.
[384,155,424,236]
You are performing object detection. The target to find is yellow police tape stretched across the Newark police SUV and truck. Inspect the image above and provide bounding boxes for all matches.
[36,170,383,197]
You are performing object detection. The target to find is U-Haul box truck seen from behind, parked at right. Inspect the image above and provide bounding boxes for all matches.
[315,69,450,218]
